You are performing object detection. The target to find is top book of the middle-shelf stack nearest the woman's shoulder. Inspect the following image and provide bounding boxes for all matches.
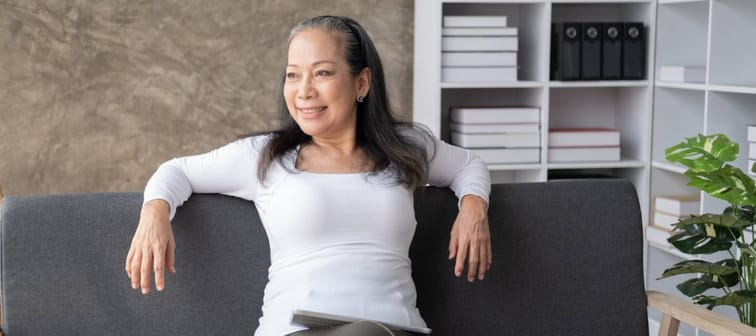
[449,106,541,124]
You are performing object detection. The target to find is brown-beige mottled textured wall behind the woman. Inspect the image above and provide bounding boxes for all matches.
[0,0,414,195]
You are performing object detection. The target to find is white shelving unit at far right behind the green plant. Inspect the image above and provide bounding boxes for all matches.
[647,0,756,335]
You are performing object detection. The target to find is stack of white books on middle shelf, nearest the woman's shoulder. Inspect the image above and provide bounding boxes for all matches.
[449,106,541,164]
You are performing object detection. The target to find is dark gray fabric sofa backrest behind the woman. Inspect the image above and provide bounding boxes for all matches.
[0,180,648,336]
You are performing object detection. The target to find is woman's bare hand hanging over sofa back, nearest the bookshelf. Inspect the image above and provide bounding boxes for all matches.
[449,195,493,282]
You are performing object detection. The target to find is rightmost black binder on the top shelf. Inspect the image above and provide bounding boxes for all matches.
[622,22,646,79]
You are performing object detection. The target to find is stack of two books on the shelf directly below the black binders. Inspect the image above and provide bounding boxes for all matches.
[548,128,620,162]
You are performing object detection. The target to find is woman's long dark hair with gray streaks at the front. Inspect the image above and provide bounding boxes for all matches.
[258,16,433,190]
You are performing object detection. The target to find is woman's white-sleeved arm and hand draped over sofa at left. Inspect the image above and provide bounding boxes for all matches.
[125,137,262,294]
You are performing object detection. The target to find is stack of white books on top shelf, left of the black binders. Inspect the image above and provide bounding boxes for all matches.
[441,15,518,82]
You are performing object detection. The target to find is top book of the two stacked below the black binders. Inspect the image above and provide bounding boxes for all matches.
[549,128,620,147]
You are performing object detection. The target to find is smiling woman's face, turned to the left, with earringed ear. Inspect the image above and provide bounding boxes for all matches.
[284,29,369,139]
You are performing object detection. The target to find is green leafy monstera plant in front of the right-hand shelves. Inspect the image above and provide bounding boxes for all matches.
[660,134,756,327]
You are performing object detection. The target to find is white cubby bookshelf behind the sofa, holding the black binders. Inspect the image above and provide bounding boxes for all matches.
[413,0,656,197]
